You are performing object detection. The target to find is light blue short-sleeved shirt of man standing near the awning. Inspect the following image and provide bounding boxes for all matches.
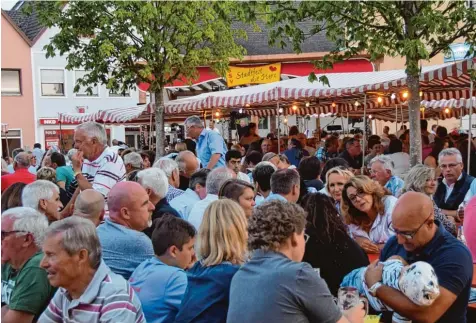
[197,129,227,168]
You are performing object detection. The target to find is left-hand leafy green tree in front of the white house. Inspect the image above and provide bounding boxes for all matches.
[29,1,254,156]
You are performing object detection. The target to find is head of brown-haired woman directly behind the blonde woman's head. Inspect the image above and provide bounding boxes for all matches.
[218,179,256,219]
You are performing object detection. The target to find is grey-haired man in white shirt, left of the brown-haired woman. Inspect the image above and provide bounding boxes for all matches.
[188,167,236,231]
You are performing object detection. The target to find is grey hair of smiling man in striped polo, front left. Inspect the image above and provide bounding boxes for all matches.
[46,216,102,269]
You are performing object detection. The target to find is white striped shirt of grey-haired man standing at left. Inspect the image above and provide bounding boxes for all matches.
[81,147,126,197]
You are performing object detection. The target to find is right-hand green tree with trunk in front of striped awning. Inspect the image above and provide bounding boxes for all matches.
[268,1,476,166]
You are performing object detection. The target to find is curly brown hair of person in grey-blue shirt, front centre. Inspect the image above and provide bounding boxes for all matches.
[248,200,307,251]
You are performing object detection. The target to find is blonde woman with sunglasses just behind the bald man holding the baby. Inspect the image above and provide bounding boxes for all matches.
[401,165,457,237]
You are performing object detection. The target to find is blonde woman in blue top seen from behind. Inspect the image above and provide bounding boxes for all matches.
[175,199,248,323]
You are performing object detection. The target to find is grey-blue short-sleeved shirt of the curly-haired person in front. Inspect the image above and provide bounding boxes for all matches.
[227,250,342,323]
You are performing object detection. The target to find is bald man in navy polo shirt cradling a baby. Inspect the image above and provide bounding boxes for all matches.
[365,192,473,323]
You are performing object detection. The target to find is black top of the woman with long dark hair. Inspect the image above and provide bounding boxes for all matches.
[302,227,369,296]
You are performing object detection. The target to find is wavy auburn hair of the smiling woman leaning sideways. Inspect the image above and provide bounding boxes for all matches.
[341,175,392,228]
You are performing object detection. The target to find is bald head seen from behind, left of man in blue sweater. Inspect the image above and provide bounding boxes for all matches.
[73,189,106,226]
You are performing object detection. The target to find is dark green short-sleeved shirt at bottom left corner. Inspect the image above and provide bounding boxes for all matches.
[2,252,56,318]
